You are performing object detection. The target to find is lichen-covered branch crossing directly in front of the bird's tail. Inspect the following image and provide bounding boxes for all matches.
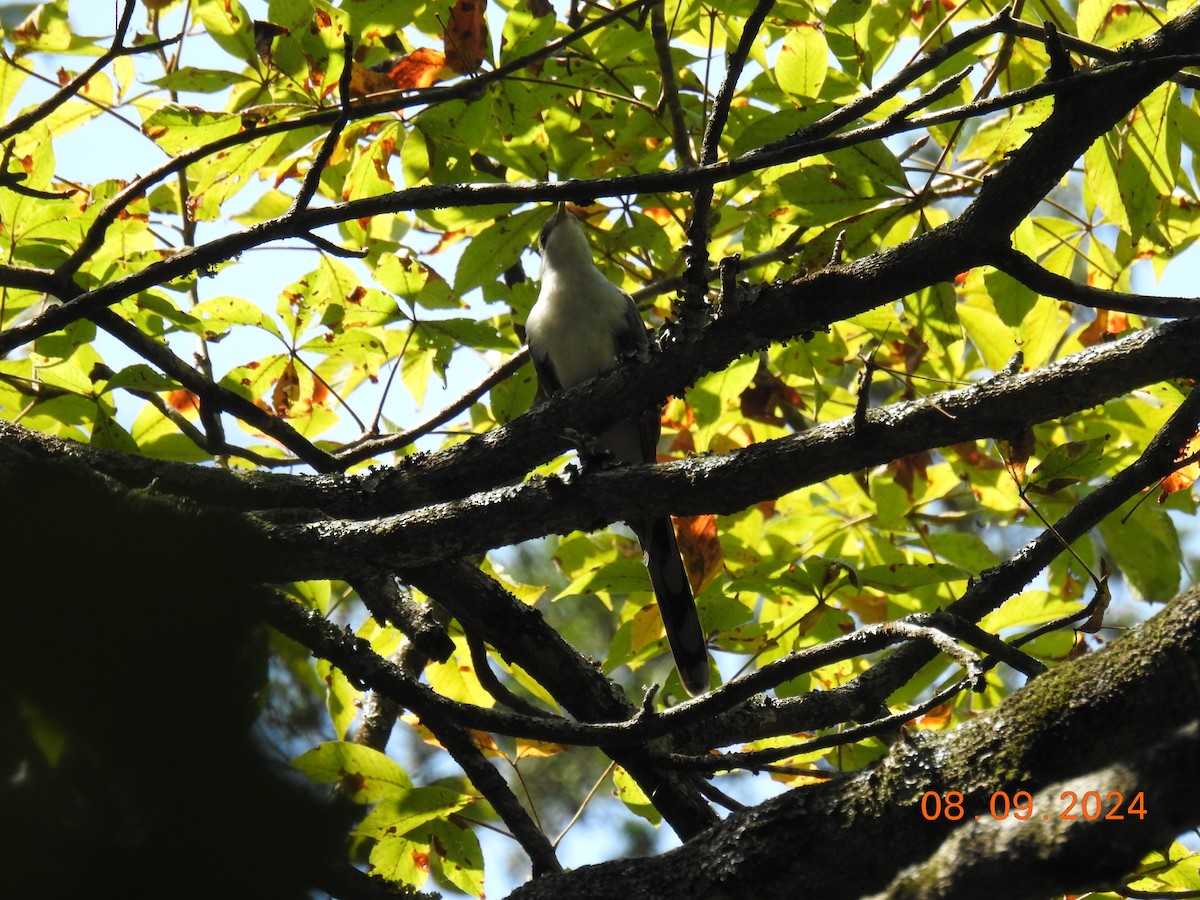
[255,322,1200,577]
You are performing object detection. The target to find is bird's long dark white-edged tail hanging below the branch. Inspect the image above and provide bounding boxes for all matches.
[634,516,709,697]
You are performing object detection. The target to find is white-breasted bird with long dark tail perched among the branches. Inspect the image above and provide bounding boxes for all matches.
[526,203,709,696]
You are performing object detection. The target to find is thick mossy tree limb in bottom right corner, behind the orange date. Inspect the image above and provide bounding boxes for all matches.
[512,589,1200,900]
